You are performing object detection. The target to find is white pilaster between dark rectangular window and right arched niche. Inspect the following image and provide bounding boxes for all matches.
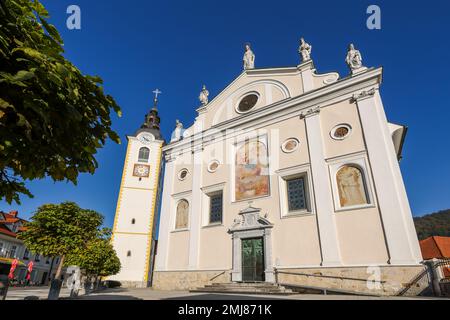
[305,107,341,266]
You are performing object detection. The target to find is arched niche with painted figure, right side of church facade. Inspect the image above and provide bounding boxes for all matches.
[336,165,369,207]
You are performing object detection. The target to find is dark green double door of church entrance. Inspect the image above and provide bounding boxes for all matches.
[242,238,264,281]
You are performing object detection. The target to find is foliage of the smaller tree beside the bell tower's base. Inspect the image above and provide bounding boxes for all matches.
[66,232,120,277]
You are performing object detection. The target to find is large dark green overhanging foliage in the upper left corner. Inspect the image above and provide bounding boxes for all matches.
[0,0,121,203]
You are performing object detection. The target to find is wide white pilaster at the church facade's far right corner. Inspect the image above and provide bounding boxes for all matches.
[354,89,422,265]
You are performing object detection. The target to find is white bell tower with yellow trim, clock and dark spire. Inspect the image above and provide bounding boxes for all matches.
[108,89,164,287]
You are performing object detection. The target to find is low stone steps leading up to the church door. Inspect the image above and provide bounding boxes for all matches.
[189,282,296,295]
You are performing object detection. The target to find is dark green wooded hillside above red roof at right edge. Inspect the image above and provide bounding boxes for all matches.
[414,209,450,240]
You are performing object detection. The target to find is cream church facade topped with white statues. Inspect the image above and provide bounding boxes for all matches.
[152,39,422,294]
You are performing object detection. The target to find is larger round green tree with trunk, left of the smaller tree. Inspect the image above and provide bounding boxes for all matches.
[19,202,105,279]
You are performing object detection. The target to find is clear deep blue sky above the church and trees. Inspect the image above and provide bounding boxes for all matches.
[0,0,450,226]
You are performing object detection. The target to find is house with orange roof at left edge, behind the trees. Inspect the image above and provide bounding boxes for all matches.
[0,211,59,285]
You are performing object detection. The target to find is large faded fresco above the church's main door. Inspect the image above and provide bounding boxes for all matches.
[235,141,269,201]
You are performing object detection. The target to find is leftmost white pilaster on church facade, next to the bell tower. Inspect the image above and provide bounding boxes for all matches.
[155,159,175,271]
